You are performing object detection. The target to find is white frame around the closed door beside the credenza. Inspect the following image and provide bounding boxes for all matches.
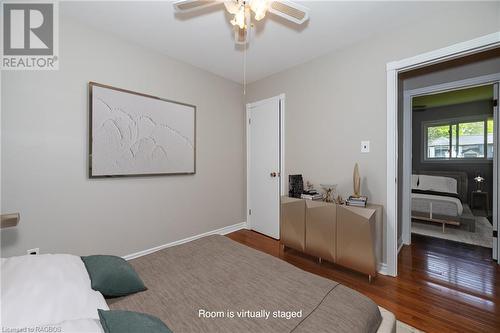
[245,93,285,229]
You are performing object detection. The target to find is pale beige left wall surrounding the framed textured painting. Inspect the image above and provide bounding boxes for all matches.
[1,15,246,257]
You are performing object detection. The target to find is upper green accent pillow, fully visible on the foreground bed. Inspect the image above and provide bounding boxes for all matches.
[82,255,147,297]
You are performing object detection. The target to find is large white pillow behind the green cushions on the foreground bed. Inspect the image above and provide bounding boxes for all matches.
[1,254,109,328]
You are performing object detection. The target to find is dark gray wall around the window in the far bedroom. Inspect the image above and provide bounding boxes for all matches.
[412,101,493,207]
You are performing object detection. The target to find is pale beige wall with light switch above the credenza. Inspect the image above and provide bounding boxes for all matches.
[246,2,500,264]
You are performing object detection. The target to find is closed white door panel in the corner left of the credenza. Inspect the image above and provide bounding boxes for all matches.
[247,97,281,239]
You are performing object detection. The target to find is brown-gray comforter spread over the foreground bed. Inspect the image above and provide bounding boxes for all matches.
[108,236,381,333]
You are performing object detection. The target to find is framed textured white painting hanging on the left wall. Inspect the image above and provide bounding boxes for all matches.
[89,83,196,177]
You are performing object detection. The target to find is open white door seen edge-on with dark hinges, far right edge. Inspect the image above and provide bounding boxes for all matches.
[493,83,500,263]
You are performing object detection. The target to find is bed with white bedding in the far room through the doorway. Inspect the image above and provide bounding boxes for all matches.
[411,171,475,232]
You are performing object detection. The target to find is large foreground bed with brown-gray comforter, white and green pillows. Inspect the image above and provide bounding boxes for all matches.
[0,236,396,333]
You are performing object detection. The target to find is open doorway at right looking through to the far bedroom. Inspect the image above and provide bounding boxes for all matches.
[396,48,500,274]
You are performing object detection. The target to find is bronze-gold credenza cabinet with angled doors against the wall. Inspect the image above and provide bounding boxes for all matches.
[280,197,383,279]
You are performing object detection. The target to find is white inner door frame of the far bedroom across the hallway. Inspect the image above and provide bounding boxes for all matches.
[398,72,500,259]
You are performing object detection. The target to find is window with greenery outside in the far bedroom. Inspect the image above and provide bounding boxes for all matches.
[424,117,493,160]
